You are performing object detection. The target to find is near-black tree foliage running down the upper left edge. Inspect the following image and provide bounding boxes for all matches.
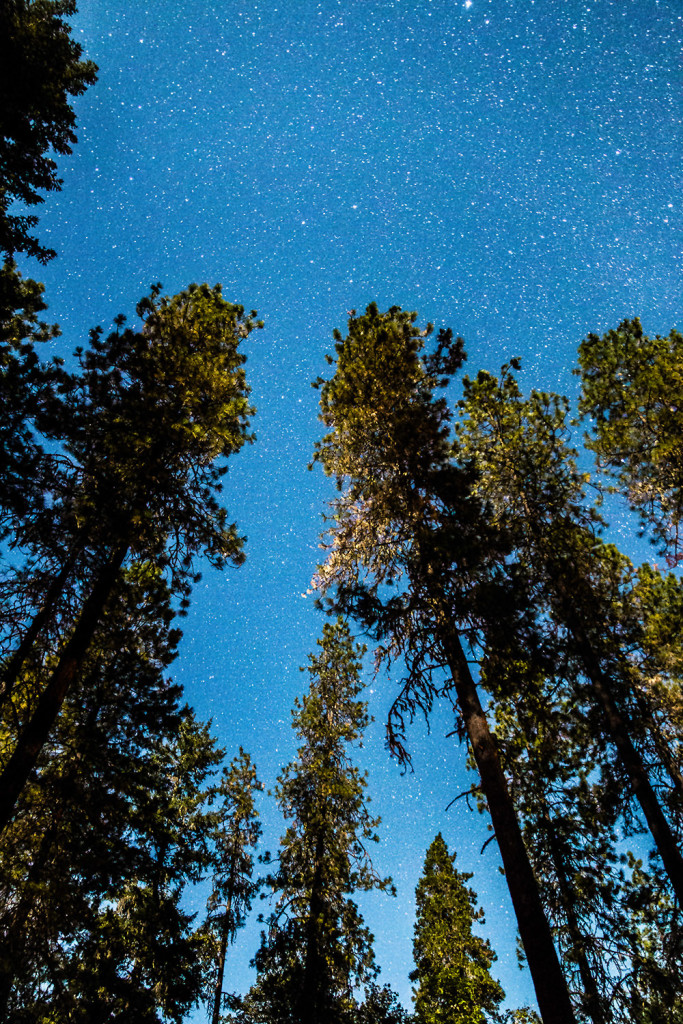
[0,0,97,699]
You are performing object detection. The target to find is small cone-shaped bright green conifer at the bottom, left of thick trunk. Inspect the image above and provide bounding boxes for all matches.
[411,833,505,1024]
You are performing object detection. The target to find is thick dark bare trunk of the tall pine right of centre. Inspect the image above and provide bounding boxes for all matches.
[442,630,575,1024]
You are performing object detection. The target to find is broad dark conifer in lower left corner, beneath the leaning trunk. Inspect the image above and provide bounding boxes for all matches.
[0,564,221,1024]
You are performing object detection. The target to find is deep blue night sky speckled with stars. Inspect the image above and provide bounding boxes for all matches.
[24,0,683,1020]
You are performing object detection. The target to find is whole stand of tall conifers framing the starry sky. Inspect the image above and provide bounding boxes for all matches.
[0,0,683,1024]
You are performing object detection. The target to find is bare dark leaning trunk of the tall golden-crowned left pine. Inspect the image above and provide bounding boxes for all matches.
[0,544,128,833]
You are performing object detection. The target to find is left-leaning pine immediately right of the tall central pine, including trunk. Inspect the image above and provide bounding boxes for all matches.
[459,367,683,901]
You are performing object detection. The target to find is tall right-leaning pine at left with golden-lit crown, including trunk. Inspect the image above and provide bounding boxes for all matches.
[0,286,262,826]
